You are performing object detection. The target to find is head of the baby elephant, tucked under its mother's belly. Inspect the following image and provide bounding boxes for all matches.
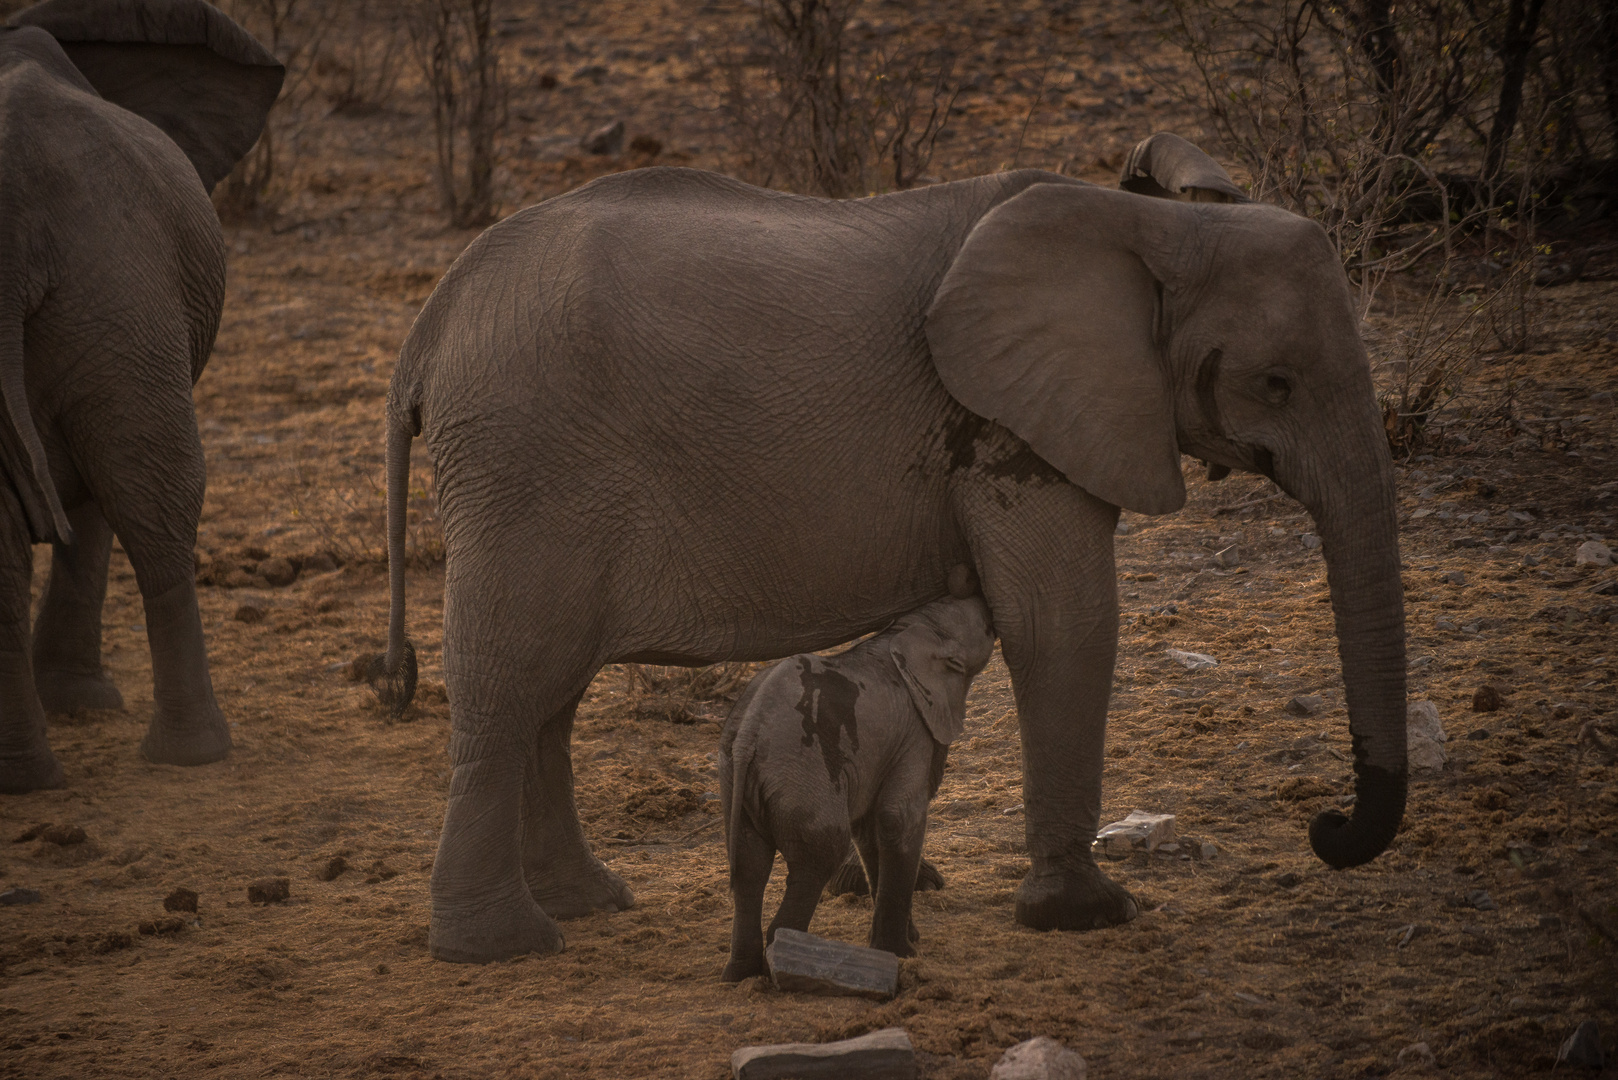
[887,596,995,746]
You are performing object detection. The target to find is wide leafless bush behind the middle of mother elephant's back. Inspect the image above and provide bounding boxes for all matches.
[714,0,959,198]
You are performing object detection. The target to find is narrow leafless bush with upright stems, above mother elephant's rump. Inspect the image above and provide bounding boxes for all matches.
[408,0,506,228]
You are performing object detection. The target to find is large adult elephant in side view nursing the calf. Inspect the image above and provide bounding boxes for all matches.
[382,139,1404,960]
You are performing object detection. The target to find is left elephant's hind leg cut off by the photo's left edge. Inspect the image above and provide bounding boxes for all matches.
[0,484,61,795]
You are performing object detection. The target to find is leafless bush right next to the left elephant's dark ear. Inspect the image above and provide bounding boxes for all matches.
[214,0,337,219]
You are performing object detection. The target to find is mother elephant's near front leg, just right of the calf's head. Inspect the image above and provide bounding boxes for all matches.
[972,481,1139,929]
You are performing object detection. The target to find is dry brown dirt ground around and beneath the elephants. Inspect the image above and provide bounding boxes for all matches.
[0,2,1618,1078]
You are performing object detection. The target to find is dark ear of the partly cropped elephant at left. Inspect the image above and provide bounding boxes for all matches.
[10,0,286,191]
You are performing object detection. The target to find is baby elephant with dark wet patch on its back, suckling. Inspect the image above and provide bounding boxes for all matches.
[718,596,995,983]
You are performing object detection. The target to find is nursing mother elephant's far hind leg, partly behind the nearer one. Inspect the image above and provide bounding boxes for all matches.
[523,691,634,918]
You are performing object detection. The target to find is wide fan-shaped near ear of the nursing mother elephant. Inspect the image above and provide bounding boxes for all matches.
[927,183,1186,513]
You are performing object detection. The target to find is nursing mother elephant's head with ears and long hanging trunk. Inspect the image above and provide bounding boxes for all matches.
[927,136,1406,866]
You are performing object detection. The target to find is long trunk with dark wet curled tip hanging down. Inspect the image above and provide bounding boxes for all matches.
[1309,431,1408,870]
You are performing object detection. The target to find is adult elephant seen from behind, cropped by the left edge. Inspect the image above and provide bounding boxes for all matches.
[0,0,283,793]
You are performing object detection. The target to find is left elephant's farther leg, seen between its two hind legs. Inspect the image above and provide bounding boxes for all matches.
[34,502,123,712]
